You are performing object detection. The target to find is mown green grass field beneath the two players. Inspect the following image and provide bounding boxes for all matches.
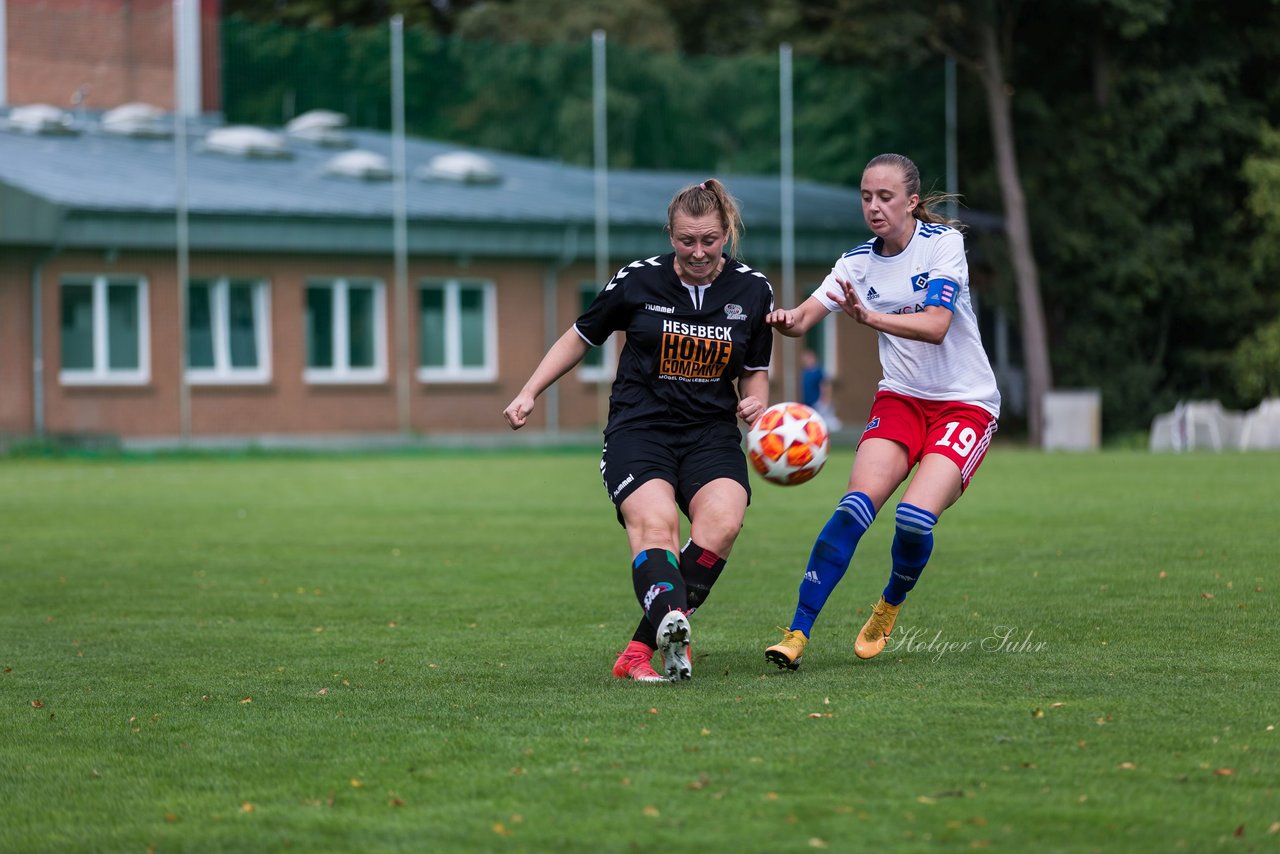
[0,448,1280,851]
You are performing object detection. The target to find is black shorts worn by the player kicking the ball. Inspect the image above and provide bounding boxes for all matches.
[600,421,751,524]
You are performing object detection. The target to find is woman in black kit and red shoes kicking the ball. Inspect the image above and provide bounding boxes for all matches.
[503,178,773,681]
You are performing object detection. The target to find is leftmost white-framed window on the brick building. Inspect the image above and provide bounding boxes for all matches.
[59,275,151,385]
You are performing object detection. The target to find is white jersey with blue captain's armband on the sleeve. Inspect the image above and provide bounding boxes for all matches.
[813,220,1000,417]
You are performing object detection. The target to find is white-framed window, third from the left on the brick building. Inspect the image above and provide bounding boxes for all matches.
[305,279,387,383]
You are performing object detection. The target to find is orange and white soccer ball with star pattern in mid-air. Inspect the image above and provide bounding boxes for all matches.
[746,403,831,487]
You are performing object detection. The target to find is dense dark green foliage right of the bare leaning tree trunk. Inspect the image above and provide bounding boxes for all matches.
[1019,3,1277,431]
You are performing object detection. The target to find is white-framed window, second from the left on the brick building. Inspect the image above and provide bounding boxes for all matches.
[187,278,271,383]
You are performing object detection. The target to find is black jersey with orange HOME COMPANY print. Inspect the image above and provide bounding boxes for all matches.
[573,252,773,435]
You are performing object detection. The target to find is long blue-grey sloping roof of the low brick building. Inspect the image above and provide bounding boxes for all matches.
[0,113,998,264]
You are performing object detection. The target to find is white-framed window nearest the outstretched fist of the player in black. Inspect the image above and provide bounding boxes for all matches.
[417,279,498,382]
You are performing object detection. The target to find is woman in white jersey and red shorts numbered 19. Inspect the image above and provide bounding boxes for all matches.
[764,154,1000,670]
